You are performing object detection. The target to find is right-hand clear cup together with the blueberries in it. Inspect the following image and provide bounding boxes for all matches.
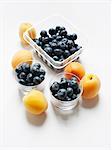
[50,72,83,110]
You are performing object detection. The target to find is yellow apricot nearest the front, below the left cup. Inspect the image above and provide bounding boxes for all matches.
[23,89,48,115]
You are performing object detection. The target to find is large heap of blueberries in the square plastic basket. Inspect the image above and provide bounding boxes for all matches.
[33,26,81,61]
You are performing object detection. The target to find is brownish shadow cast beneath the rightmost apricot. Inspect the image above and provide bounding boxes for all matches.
[81,95,99,108]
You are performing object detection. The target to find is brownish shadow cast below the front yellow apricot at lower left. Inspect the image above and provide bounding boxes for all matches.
[26,111,47,126]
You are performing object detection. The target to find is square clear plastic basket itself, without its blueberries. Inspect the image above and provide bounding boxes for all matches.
[23,15,83,71]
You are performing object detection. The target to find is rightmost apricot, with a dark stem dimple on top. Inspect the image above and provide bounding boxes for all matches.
[81,74,101,99]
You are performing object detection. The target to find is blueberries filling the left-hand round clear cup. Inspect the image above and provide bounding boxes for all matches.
[15,63,46,86]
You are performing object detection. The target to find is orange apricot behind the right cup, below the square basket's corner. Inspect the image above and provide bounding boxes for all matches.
[64,62,85,79]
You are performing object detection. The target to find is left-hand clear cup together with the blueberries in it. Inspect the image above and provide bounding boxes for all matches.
[14,60,46,94]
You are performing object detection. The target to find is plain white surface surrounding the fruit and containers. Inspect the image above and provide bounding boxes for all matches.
[1,3,110,148]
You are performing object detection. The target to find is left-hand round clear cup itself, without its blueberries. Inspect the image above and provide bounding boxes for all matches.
[13,60,46,95]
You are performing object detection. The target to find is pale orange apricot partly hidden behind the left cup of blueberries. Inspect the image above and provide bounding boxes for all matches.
[11,50,33,69]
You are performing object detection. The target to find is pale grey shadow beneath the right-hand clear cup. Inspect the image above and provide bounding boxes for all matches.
[52,103,80,120]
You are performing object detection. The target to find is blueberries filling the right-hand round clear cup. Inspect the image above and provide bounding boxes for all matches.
[50,77,81,101]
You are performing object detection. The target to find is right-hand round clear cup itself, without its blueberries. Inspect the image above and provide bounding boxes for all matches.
[49,72,83,111]
